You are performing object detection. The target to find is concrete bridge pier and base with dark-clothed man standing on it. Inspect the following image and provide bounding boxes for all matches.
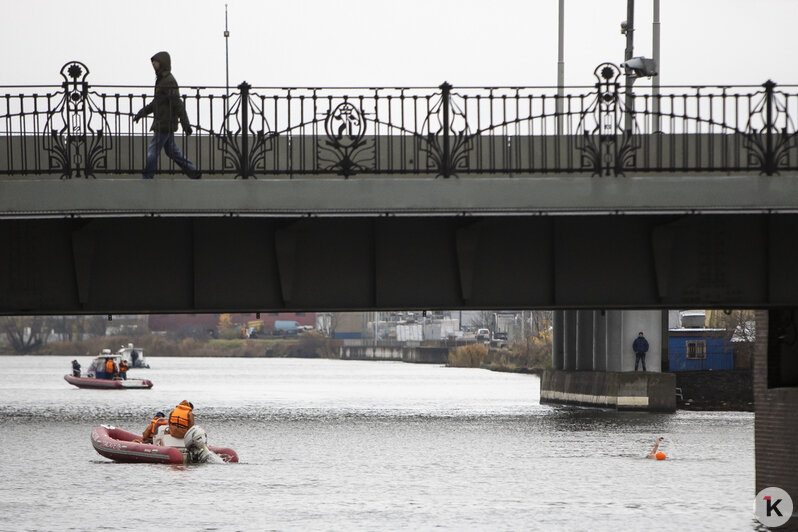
[540,310,676,412]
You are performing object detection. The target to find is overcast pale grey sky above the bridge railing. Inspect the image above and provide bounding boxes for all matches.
[0,0,798,86]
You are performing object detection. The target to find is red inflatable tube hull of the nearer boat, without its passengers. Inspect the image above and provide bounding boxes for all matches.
[91,425,238,464]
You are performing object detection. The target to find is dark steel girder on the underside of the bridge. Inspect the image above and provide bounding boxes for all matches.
[0,214,798,314]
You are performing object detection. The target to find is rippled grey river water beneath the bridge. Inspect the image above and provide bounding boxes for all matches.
[0,357,757,532]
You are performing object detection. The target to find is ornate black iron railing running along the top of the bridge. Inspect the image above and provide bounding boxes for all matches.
[0,61,798,179]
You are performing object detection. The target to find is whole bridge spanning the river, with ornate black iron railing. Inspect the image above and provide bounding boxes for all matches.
[0,61,798,512]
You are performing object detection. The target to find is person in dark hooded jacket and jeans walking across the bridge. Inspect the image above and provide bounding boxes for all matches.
[133,52,202,179]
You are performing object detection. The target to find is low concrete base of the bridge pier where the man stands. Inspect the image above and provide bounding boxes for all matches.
[540,370,676,412]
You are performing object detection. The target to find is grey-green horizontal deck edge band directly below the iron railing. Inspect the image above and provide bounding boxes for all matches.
[0,174,798,218]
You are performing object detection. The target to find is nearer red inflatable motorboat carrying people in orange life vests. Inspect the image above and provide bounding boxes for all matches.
[91,425,238,464]
